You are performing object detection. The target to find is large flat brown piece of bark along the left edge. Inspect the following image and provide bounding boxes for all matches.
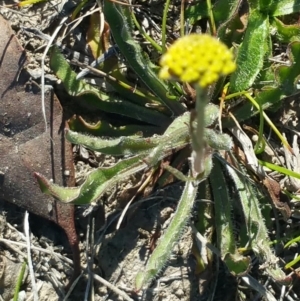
[0,16,80,282]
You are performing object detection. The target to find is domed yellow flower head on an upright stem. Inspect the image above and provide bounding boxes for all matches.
[159,34,236,88]
